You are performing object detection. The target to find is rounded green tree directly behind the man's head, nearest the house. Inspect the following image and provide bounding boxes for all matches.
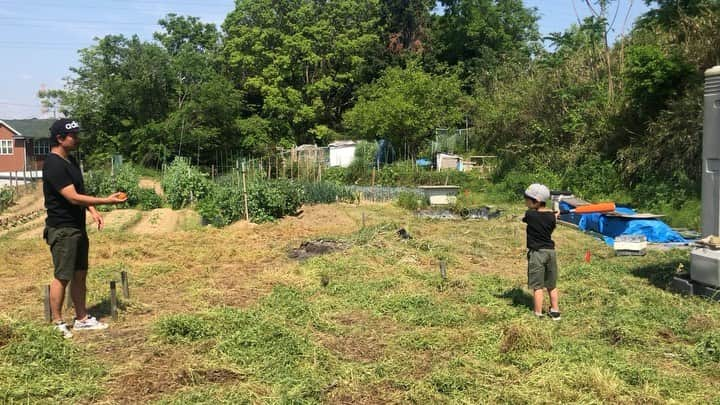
[66,35,173,166]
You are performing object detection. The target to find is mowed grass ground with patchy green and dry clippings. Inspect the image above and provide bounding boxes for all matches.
[0,205,720,404]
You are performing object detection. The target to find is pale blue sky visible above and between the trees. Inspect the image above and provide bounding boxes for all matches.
[0,0,647,119]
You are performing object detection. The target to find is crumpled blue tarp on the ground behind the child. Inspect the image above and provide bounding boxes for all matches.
[560,202,688,246]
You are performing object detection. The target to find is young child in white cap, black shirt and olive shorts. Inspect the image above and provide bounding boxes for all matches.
[523,184,560,321]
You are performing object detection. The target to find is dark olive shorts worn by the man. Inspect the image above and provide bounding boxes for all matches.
[43,226,90,281]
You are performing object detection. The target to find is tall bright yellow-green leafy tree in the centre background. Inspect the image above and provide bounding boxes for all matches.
[223,0,381,148]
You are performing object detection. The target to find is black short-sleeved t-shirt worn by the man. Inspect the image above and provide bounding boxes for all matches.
[43,153,85,231]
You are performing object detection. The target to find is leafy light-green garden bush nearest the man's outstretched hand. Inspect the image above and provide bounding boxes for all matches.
[162,156,210,209]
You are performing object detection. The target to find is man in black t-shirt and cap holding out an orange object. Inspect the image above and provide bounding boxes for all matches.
[43,118,127,338]
